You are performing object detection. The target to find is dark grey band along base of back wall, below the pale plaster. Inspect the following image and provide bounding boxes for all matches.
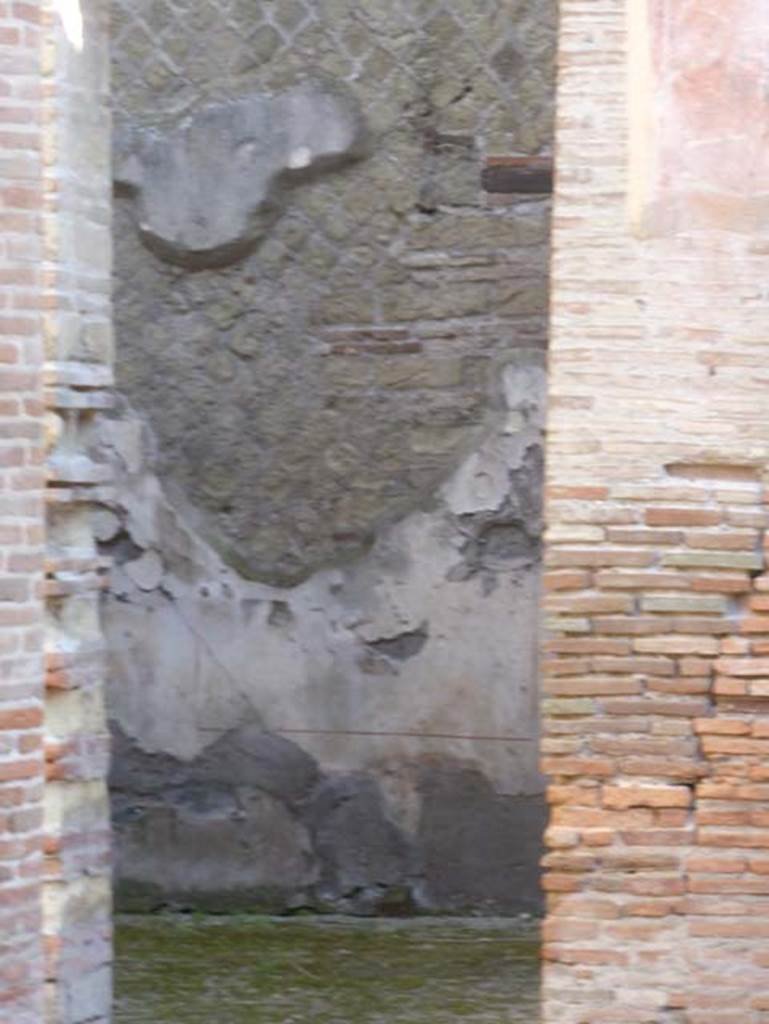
[111,726,546,914]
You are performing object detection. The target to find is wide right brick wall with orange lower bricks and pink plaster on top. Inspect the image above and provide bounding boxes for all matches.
[544,0,769,1024]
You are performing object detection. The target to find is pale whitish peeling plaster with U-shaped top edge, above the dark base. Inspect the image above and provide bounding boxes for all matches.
[96,354,544,907]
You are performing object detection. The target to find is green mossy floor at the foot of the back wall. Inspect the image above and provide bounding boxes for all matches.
[115,916,539,1024]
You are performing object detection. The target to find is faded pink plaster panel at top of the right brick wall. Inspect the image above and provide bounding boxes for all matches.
[649,0,769,232]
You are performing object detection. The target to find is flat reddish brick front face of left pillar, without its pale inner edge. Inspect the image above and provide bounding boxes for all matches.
[0,4,44,1024]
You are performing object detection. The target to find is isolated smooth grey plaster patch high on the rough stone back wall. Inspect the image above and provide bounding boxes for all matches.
[115,84,365,269]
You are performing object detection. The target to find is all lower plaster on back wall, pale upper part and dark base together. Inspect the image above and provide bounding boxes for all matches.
[102,389,542,913]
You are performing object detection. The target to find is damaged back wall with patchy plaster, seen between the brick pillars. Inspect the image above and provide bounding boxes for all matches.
[105,0,555,912]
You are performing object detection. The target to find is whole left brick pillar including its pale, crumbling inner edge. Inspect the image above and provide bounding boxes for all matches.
[0,3,111,1024]
